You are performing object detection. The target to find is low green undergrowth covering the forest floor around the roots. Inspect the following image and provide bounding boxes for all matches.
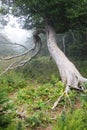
[0,57,87,130]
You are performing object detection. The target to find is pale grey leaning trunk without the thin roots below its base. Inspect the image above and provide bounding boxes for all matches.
[46,25,87,90]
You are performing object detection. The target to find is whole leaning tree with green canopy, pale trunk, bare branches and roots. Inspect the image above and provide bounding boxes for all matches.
[1,0,87,109]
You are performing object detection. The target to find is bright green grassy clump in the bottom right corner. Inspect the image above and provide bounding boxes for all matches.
[53,109,87,130]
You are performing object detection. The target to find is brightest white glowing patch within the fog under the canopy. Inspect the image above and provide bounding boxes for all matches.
[4,16,32,44]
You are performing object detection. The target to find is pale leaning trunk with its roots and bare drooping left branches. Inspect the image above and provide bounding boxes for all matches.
[0,24,87,109]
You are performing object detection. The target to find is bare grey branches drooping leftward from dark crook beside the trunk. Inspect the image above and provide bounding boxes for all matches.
[0,29,45,76]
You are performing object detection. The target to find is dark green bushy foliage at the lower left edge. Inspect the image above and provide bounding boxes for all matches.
[0,86,11,129]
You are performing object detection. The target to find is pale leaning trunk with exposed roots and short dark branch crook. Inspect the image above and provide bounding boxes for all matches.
[34,23,87,110]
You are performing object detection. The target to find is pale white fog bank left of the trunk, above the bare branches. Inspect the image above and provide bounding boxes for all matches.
[0,15,34,55]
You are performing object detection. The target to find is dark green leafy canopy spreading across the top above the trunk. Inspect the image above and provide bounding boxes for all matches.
[0,0,87,33]
